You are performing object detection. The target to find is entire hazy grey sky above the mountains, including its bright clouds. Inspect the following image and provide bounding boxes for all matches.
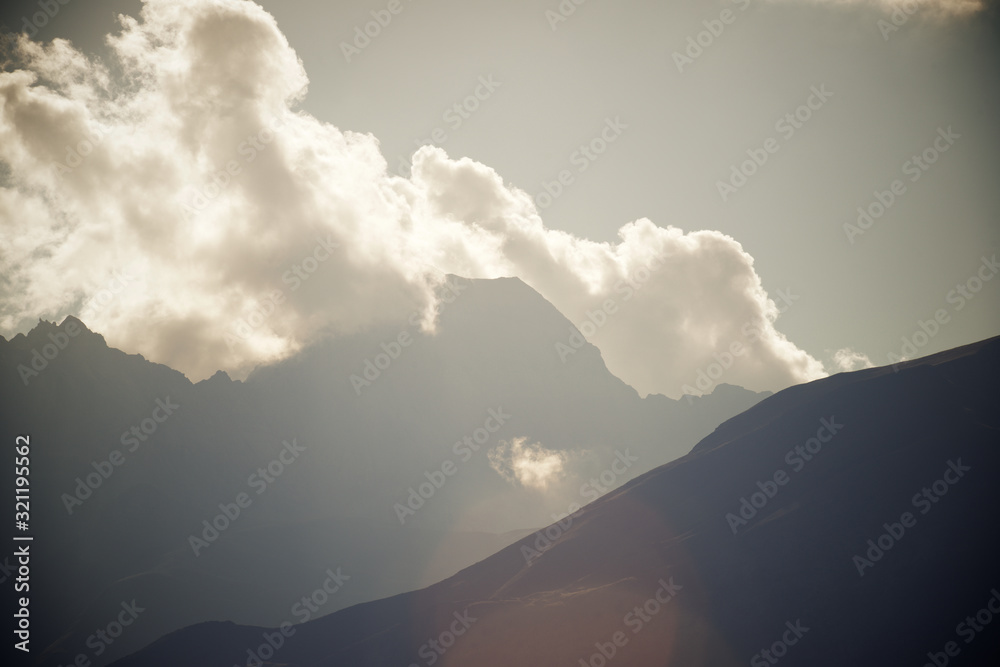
[0,0,1000,397]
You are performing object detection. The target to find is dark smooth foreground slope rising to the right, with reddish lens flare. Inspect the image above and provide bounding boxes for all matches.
[105,338,1000,667]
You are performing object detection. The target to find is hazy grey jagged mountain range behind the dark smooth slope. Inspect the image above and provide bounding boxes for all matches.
[0,279,766,665]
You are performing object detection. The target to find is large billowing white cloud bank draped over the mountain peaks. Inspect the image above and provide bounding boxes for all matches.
[0,0,824,396]
